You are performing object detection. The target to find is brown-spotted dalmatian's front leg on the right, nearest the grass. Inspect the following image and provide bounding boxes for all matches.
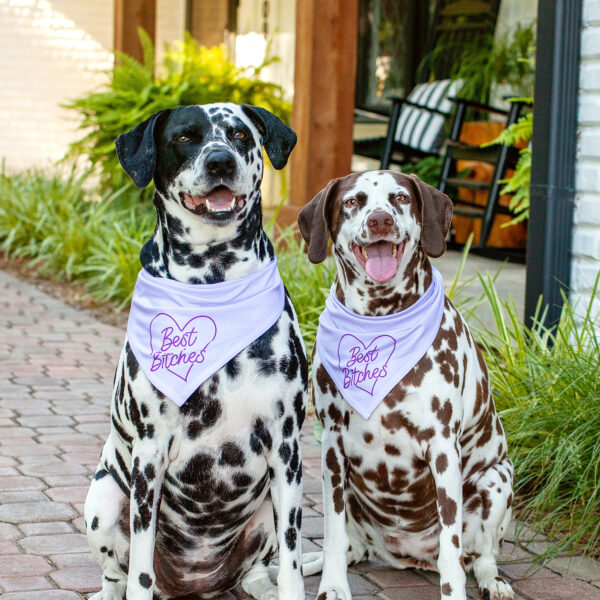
[427,435,467,600]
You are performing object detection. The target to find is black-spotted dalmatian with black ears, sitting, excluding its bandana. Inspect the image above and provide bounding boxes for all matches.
[85,104,308,600]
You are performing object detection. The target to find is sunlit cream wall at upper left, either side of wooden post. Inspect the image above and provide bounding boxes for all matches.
[0,0,185,170]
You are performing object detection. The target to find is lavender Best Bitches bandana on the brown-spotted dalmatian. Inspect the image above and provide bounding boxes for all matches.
[316,267,444,419]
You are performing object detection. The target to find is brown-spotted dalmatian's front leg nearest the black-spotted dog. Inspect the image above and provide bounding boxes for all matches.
[317,418,352,600]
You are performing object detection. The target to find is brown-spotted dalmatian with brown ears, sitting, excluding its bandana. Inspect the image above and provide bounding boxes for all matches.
[299,171,513,600]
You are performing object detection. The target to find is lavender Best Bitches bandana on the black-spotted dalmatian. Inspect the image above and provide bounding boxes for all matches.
[127,260,285,406]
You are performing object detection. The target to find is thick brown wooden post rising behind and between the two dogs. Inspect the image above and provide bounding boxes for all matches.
[278,0,358,226]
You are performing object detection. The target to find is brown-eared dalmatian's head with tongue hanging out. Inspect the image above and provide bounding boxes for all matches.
[298,171,452,282]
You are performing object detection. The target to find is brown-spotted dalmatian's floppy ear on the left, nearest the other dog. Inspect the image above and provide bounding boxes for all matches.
[298,179,339,264]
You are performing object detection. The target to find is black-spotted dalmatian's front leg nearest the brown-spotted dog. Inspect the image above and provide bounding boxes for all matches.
[269,424,304,600]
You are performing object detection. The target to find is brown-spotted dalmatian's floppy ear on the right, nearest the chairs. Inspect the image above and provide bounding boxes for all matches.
[410,175,452,258]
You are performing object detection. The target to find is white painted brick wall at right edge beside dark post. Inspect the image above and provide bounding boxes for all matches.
[571,0,600,314]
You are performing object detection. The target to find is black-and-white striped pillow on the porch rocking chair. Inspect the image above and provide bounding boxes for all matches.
[394,79,462,153]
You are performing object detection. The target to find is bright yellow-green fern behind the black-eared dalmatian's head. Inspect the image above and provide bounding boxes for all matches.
[65,30,291,188]
